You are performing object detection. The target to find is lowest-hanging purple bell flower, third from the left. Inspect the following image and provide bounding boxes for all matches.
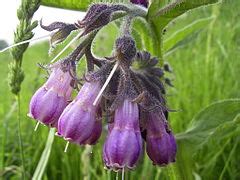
[103,99,142,170]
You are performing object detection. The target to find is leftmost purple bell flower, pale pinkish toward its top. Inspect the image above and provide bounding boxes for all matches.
[28,66,73,127]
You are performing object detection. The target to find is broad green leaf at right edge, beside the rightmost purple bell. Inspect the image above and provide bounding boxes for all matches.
[177,99,240,147]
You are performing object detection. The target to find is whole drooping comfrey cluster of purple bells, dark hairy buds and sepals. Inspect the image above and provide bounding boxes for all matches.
[29,1,177,170]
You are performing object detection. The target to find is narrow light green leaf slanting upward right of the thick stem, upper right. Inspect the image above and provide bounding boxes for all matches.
[163,17,213,52]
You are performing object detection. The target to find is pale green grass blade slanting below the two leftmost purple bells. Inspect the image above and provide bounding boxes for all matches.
[32,128,55,179]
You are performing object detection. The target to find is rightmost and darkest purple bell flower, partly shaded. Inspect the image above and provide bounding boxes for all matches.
[146,112,177,166]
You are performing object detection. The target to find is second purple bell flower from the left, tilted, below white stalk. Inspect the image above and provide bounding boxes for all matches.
[58,81,102,145]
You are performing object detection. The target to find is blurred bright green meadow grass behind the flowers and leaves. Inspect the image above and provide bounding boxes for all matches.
[0,1,240,180]
